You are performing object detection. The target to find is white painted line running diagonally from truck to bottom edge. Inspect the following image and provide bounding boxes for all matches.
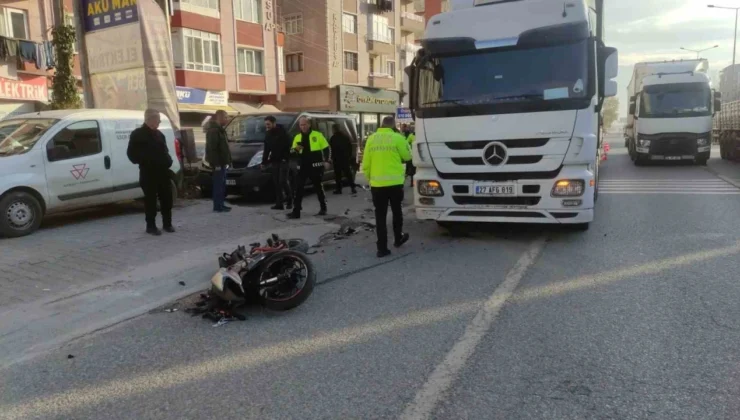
[401,237,545,420]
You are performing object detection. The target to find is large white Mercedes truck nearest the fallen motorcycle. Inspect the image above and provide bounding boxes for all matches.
[406,0,618,230]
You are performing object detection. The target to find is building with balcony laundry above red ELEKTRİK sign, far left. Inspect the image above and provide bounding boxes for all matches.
[0,0,52,118]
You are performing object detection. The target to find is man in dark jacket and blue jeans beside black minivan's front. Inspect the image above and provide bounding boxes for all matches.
[206,110,231,213]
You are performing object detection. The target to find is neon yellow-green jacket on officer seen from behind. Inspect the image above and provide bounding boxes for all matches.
[362,128,411,187]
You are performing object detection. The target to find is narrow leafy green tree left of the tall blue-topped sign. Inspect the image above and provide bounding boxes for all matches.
[51,24,82,109]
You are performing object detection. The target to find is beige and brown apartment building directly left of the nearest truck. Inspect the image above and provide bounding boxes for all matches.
[281,0,424,137]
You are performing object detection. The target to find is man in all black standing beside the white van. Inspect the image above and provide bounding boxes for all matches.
[126,109,175,236]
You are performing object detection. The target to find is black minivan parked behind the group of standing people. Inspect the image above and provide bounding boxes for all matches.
[198,112,358,197]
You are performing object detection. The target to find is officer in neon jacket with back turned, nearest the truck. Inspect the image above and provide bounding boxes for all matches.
[362,117,411,258]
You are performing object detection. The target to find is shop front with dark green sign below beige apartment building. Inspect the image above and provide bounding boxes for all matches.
[337,85,400,145]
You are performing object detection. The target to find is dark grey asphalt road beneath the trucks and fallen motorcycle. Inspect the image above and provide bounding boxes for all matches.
[0,137,740,420]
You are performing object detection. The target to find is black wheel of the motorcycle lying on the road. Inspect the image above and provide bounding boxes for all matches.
[257,250,316,311]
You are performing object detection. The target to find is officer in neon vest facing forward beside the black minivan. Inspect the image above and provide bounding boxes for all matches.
[288,117,329,219]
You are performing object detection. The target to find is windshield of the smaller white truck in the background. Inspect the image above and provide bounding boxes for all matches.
[640,83,712,118]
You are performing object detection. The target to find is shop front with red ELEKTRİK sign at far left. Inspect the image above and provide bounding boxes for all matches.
[0,74,49,119]
